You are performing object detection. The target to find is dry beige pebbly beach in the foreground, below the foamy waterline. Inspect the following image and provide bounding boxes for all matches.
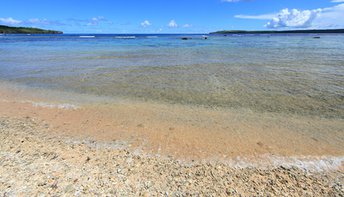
[0,117,344,196]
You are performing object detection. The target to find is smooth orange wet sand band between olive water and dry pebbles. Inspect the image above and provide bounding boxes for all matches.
[0,82,344,160]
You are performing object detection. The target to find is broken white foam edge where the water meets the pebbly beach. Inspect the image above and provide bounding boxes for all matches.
[66,135,344,173]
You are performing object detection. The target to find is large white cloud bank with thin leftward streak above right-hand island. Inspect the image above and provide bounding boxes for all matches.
[234,3,344,29]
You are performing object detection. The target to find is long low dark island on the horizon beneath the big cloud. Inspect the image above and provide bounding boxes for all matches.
[210,29,344,34]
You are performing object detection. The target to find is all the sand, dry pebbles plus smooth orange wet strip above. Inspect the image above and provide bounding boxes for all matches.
[0,82,344,196]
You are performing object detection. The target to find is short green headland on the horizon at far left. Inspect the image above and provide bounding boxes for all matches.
[0,25,63,34]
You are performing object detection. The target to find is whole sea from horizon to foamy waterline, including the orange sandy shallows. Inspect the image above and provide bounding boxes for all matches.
[0,34,344,163]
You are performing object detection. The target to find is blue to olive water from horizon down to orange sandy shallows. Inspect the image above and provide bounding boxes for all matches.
[0,34,344,118]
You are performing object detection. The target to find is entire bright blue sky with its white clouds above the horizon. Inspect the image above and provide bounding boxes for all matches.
[0,0,344,33]
